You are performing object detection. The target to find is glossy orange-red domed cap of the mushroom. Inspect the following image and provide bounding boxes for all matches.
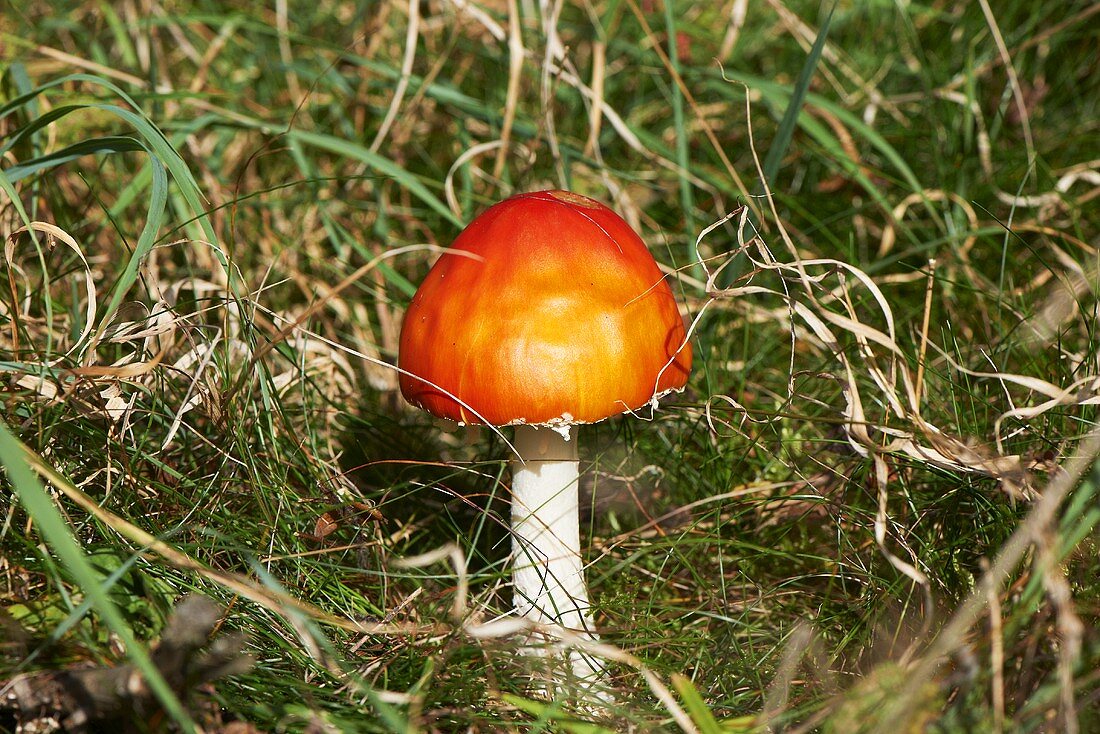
[398,191,691,426]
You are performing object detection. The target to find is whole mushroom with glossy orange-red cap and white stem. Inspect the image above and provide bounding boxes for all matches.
[398,190,691,679]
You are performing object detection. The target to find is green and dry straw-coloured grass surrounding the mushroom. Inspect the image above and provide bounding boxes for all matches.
[0,0,1100,733]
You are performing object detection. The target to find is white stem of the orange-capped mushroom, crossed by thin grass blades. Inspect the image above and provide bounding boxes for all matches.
[512,426,603,680]
